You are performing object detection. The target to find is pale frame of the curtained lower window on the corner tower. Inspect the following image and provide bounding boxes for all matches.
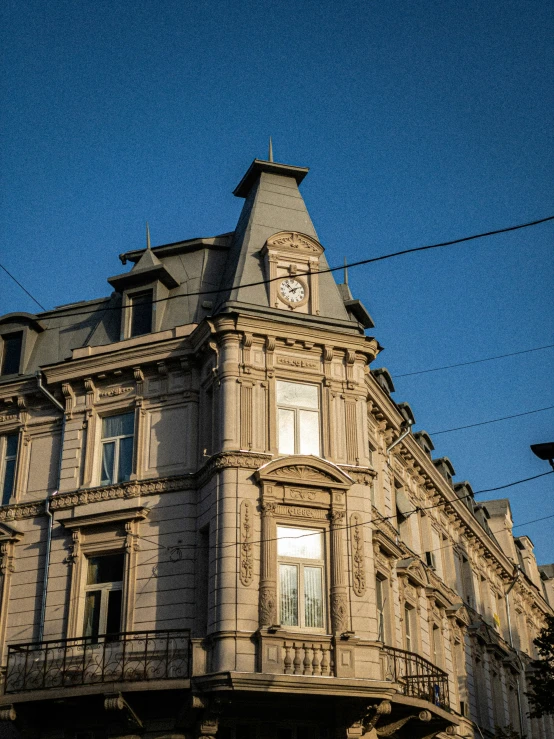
[276,521,329,634]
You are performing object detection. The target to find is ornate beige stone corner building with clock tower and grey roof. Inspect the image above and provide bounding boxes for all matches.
[0,155,554,739]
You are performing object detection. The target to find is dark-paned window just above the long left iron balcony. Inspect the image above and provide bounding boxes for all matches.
[83,554,124,642]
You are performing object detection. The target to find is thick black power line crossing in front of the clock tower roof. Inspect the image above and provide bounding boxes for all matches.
[37,216,554,316]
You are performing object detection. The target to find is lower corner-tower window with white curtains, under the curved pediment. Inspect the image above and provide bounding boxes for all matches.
[277,526,325,631]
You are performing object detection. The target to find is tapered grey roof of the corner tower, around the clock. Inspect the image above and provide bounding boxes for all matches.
[213,159,359,330]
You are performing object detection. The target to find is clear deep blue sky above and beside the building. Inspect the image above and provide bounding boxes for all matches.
[0,0,554,562]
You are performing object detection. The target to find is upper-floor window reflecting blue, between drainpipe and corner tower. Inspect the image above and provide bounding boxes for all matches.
[100,413,135,485]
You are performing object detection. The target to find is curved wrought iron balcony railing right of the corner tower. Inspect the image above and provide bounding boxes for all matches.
[381,647,450,709]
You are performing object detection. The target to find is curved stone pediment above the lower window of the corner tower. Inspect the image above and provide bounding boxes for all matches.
[256,455,354,490]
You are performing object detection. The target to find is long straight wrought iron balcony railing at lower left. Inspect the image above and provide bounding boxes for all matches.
[4,629,190,693]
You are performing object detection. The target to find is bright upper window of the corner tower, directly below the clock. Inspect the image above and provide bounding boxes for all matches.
[277,380,320,456]
